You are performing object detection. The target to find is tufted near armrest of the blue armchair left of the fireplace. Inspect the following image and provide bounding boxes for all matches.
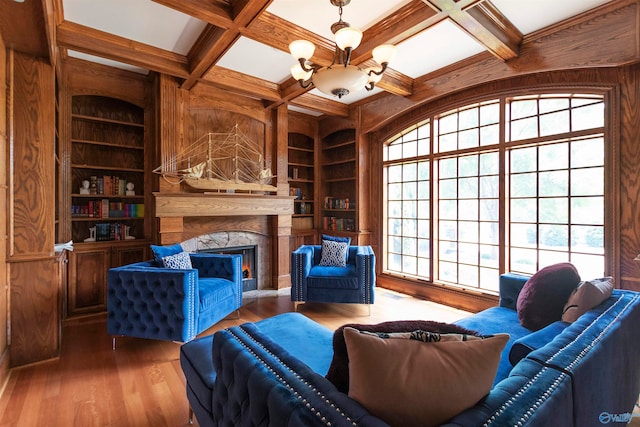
[107,266,198,342]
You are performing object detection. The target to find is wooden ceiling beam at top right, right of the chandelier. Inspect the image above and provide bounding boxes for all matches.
[422,0,522,61]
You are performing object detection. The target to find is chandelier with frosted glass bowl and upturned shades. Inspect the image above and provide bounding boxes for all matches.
[289,0,396,98]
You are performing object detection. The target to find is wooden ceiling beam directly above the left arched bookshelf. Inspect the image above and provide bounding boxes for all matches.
[56,21,189,78]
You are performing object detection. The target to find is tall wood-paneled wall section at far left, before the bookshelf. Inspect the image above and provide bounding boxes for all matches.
[7,51,60,366]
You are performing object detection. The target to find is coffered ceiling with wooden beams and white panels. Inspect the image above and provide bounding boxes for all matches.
[0,0,608,115]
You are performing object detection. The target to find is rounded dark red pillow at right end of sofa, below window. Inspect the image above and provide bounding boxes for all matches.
[516,262,580,331]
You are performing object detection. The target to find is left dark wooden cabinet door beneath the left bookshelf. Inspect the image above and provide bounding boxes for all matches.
[67,246,111,316]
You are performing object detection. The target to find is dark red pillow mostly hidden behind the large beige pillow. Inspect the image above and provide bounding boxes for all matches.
[326,320,477,393]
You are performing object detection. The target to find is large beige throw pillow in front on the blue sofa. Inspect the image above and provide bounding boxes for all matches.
[344,328,509,427]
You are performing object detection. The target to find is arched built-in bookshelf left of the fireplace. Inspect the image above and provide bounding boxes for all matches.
[69,95,145,242]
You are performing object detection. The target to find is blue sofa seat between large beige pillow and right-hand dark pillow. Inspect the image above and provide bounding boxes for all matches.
[454,307,531,385]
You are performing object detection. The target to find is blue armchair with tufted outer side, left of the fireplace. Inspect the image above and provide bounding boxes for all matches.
[107,253,242,348]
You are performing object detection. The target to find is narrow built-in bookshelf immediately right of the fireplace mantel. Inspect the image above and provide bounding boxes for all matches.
[288,133,316,231]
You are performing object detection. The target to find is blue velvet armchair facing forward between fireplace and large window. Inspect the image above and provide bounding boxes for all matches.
[291,245,376,309]
